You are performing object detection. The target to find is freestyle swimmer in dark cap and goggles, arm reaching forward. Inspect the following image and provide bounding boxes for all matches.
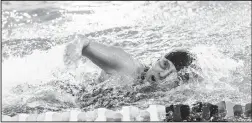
[65,35,197,88]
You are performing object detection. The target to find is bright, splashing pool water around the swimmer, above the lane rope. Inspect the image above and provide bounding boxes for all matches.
[2,1,251,115]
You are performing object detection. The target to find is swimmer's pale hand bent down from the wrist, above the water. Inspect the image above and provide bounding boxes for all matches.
[63,34,90,68]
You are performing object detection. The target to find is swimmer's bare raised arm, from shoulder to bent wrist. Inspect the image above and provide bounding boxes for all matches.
[64,36,141,74]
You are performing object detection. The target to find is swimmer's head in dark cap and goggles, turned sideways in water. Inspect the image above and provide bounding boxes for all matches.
[145,50,194,84]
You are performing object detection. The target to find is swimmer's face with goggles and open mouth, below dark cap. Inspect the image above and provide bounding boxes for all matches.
[146,57,177,83]
